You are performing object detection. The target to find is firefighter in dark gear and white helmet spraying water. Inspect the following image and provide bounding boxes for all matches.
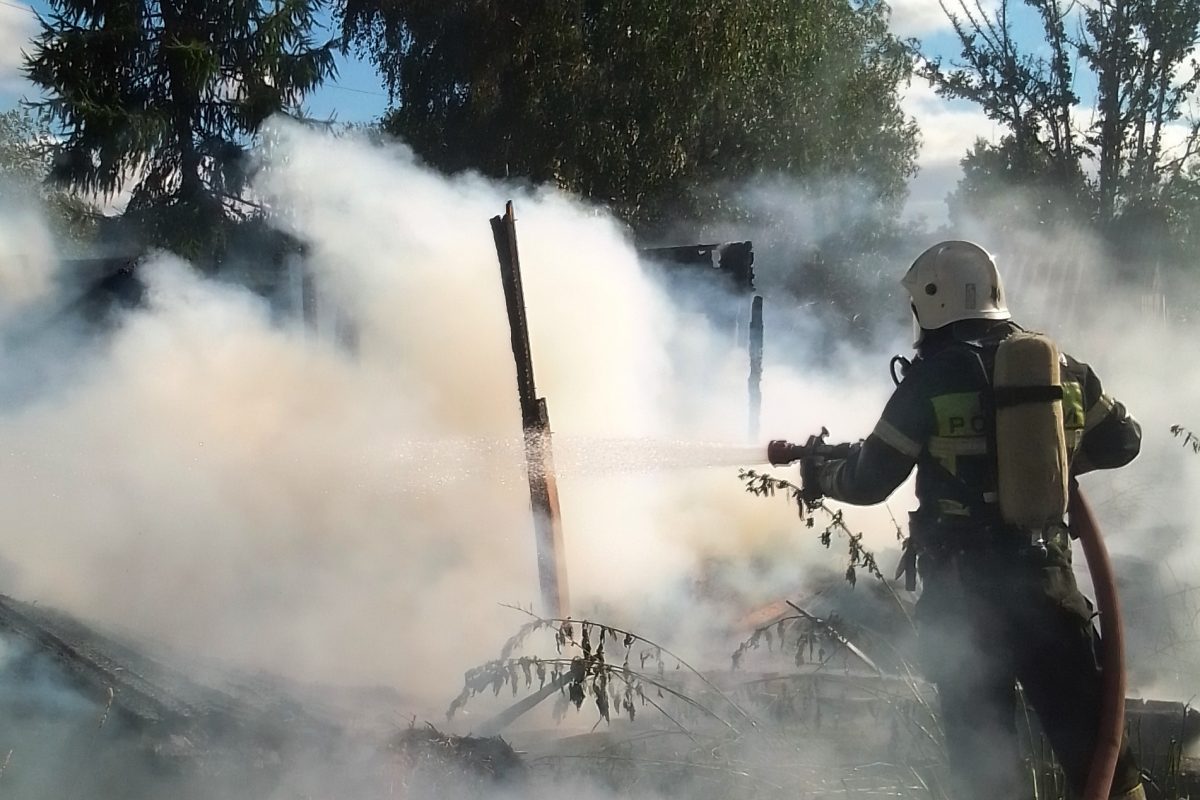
[816,241,1145,800]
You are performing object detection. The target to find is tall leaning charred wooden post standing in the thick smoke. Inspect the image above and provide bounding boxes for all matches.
[492,200,569,618]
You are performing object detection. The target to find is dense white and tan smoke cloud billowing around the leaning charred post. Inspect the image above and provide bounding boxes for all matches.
[0,117,892,710]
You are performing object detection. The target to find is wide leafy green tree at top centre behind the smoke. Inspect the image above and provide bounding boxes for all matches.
[338,0,917,231]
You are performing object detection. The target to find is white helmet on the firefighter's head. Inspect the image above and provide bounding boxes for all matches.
[900,241,1012,344]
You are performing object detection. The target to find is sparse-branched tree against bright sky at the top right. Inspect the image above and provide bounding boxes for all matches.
[923,0,1200,255]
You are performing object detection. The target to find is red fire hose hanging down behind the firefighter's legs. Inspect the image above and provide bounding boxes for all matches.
[1069,485,1126,800]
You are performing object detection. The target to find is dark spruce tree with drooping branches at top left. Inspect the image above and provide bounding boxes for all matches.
[25,0,335,264]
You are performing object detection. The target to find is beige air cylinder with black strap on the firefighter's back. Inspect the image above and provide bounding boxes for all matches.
[992,333,1068,528]
